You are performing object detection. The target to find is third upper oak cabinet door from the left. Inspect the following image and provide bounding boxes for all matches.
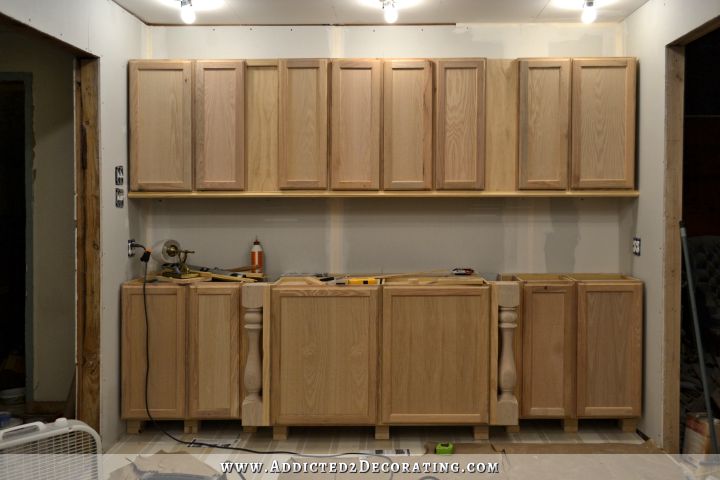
[278,60,329,190]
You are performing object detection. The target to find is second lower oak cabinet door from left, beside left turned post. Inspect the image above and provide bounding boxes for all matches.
[187,283,241,419]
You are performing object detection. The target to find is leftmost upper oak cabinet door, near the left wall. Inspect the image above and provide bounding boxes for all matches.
[129,60,192,191]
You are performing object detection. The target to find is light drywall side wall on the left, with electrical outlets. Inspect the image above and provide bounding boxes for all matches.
[0,0,146,448]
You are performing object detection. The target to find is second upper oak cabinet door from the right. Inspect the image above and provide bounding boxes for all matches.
[518,59,570,190]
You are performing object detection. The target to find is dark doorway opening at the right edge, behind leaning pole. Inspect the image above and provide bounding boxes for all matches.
[681,25,720,446]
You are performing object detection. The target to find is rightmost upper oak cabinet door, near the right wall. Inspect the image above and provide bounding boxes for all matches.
[571,58,637,189]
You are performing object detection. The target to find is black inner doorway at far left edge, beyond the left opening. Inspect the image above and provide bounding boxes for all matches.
[0,74,32,403]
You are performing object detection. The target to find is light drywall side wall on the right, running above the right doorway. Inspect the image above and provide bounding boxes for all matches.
[623,0,720,444]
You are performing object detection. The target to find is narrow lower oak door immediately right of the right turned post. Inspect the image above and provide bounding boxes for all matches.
[521,282,577,418]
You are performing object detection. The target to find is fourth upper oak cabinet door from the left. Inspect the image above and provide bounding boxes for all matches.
[330,60,382,190]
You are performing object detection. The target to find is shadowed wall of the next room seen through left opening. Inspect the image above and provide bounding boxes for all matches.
[0,26,75,401]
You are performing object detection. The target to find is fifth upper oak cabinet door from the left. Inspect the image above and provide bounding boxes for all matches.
[383,60,433,190]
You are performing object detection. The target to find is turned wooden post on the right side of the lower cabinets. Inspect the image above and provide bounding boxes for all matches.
[495,282,520,425]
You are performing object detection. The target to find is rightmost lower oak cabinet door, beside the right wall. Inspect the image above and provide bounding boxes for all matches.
[577,281,643,418]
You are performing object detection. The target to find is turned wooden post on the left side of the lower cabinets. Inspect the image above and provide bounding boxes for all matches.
[242,283,267,426]
